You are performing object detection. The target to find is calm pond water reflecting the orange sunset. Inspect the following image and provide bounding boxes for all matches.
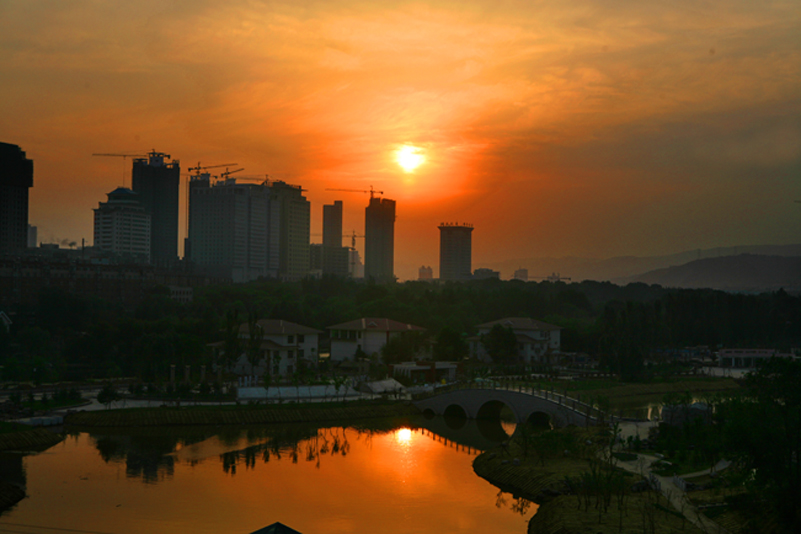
[0,420,537,534]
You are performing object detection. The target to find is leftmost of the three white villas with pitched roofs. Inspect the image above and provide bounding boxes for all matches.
[234,319,322,377]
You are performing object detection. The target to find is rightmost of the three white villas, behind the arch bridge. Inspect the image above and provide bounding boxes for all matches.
[468,317,562,363]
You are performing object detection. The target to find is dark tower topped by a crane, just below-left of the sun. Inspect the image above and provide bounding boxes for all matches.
[364,197,395,282]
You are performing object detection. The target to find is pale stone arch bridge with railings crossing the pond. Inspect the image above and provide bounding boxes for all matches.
[414,388,602,427]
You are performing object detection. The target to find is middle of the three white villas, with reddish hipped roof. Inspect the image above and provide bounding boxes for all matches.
[328,317,425,362]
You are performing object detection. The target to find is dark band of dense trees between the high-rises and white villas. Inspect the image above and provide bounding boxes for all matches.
[0,277,801,381]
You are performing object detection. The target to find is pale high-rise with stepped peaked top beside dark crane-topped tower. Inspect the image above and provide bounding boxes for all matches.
[94,187,150,262]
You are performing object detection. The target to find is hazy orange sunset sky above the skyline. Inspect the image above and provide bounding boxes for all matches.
[0,0,801,279]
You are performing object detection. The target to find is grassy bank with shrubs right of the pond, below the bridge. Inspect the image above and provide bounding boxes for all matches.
[473,428,701,534]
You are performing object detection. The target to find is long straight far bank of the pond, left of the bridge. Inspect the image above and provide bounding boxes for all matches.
[64,401,420,427]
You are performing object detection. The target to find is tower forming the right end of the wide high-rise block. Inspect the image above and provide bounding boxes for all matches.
[270,181,311,280]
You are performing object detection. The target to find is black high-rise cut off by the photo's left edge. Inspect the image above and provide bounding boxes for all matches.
[0,143,33,255]
